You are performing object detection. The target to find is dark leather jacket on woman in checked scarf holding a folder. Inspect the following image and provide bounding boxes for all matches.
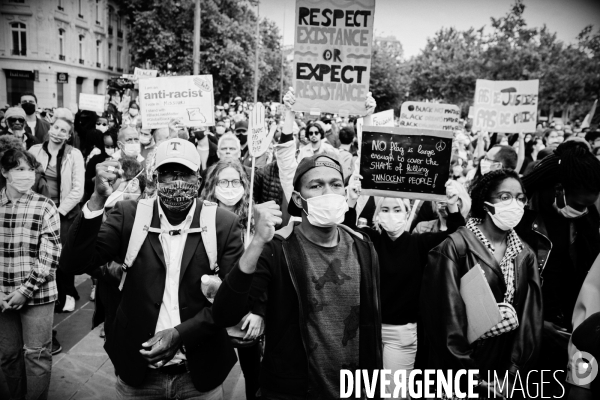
[421,228,543,379]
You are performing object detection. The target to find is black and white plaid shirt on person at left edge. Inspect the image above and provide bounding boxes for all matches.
[0,188,61,305]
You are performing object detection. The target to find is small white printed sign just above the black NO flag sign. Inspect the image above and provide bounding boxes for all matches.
[400,101,461,131]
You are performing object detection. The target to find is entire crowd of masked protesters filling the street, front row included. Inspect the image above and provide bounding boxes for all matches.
[0,2,600,400]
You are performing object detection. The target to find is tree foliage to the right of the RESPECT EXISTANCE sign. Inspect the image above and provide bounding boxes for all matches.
[410,0,600,117]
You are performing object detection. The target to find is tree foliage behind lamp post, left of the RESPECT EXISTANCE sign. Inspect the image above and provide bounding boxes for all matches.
[120,0,286,101]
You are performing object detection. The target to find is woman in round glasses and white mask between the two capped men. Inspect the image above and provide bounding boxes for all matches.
[200,160,264,400]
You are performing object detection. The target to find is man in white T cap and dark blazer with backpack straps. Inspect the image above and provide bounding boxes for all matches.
[61,139,243,400]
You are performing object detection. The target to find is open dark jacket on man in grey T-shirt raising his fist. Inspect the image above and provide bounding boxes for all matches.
[213,225,383,399]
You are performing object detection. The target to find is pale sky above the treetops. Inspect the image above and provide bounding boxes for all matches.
[260,0,600,58]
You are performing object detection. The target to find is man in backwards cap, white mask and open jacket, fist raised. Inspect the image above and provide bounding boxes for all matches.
[213,154,383,399]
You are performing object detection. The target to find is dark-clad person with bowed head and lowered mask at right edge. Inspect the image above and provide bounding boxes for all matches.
[516,141,600,394]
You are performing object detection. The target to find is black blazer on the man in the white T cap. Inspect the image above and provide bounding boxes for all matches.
[60,200,244,392]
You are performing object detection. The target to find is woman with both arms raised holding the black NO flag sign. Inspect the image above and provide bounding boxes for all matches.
[344,180,465,393]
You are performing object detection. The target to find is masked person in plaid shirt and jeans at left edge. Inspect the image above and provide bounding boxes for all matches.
[0,149,61,399]
